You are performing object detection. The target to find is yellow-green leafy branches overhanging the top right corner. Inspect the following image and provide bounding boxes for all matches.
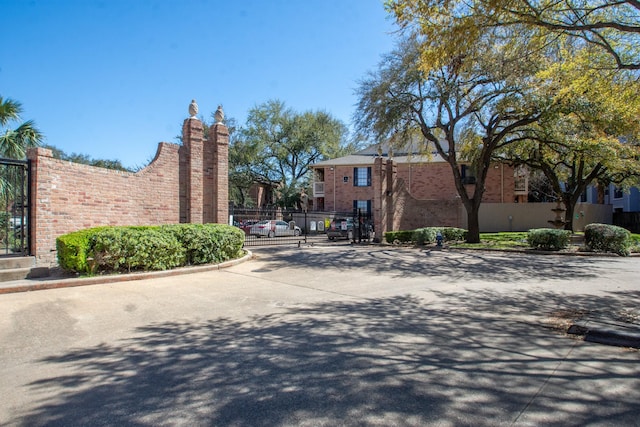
[386,0,640,70]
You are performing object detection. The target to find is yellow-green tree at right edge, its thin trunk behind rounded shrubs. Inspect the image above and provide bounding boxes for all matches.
[499,44,640,230]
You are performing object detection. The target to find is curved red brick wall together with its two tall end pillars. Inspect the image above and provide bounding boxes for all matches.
[28,118,229,266]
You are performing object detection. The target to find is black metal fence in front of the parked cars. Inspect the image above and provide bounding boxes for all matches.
[230,208,373,246]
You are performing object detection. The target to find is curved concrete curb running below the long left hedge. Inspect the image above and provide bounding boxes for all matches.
[0,249,253,294]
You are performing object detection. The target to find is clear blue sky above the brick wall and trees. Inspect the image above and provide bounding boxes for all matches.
[0,0,396,171]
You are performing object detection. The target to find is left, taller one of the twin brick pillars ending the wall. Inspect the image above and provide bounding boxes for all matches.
[180,117,204,224]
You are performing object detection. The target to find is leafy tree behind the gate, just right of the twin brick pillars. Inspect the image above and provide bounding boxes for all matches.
[230,100,349,207]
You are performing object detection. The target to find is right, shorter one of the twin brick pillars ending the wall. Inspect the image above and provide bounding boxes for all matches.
[210,123,229,224]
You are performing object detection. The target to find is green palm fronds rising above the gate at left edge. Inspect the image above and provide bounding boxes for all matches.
[0,96,44,160]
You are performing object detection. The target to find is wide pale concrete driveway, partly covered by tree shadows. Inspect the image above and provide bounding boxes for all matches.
[0,243,640,426]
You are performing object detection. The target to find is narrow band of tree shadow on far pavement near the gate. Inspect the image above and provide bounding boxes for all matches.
[255,245,626,283]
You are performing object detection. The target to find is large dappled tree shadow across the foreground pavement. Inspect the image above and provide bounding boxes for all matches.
[22,290,640,426]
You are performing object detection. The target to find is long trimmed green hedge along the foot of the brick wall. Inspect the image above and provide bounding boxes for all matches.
[56,224,244,273]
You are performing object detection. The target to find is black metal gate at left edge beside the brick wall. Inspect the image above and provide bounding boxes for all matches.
[0,158,31,256]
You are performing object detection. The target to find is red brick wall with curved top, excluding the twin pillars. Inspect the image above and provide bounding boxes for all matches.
[29,143,180,265]
